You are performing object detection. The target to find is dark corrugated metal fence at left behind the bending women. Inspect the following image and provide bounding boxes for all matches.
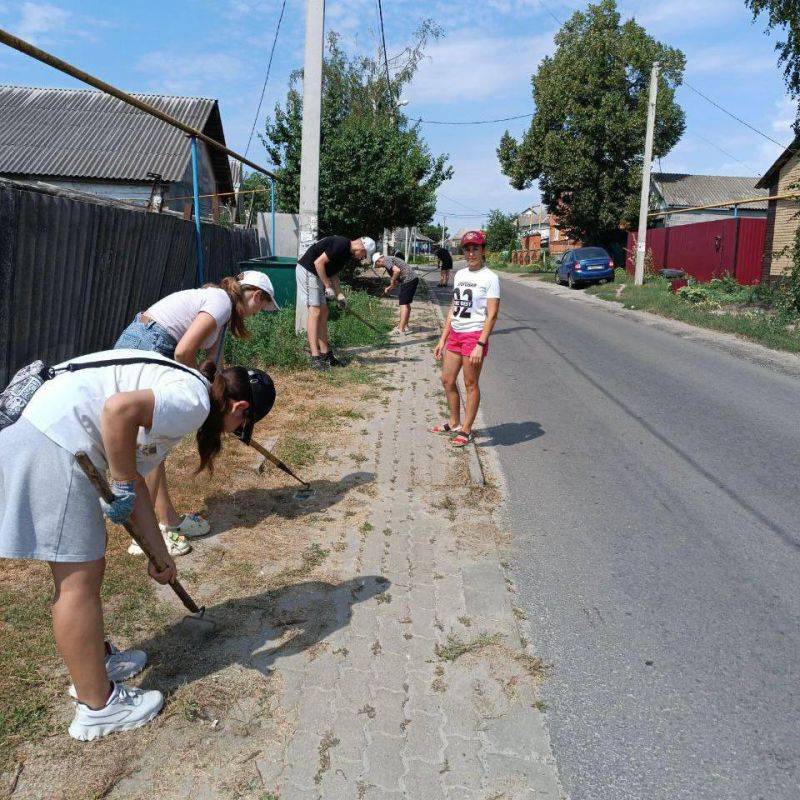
[0,180,258,387]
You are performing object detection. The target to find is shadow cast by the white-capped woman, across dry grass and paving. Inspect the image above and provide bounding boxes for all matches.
[203,467,375,538]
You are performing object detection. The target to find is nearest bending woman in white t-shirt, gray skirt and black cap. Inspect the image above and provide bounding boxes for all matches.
[0,350,275,741]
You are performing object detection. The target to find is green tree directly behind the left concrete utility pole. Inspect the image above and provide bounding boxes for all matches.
[262,21,452,237]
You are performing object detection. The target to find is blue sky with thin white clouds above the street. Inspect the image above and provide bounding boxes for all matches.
[0,0,794,228]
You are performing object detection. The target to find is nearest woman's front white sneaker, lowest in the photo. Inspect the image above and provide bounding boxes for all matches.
[69,683,164,742]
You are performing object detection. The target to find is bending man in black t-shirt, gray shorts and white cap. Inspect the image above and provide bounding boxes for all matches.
[295,236,375,370]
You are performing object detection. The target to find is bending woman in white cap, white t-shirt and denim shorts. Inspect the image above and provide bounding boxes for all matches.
[114,270,280,556]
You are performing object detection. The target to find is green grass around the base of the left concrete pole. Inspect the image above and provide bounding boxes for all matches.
[225,287,394,368]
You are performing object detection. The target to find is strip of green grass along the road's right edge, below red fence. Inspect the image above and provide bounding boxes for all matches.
[586,270,800,353]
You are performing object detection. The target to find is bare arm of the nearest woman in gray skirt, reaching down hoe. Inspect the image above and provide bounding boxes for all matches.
[100,389,177,583]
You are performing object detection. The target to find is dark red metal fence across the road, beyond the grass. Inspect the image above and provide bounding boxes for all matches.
[625,217,767,285]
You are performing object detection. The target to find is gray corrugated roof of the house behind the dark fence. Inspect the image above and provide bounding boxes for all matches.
[0,86,233,192]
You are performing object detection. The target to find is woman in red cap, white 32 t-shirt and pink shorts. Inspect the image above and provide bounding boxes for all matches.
[433,231,500,447]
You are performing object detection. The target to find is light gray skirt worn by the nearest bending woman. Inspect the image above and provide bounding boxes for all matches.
[0,417,106,562]
